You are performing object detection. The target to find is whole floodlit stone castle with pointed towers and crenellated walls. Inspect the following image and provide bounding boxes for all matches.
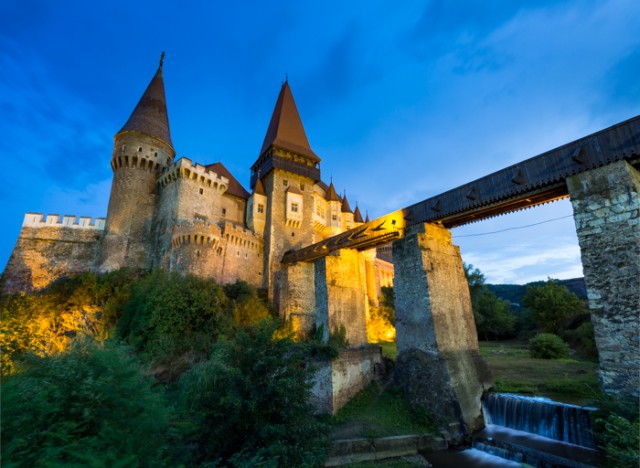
[3,55,393,318]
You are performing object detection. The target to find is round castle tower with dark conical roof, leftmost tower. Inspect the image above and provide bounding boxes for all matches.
[97,53,175,271]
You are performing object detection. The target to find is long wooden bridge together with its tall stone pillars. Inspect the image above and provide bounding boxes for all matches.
[276,116,640,431]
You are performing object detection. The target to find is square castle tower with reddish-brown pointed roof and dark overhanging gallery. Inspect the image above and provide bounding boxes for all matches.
[251,81,320,298]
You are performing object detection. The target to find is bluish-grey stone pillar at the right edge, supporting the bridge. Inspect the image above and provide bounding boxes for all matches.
[567,161,640,396]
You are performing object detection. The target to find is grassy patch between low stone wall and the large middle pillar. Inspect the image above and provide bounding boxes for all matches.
[332,382,437,439]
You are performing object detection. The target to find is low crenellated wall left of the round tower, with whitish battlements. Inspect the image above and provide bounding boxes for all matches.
[3,213,105,293]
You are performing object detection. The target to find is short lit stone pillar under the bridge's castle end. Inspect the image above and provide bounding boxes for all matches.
[277,262,316,337]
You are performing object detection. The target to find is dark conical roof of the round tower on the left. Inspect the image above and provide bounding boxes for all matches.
[118,52,173,148]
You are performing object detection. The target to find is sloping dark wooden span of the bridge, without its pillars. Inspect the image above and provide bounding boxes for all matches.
[282,116,640,263]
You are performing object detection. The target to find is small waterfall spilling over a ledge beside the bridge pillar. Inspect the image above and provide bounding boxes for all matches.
[482,393,596,449]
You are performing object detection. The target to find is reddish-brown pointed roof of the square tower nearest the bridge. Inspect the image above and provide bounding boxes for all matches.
[260,81,320,163]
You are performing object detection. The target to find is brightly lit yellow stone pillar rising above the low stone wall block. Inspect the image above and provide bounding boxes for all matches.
[315,249,367,346]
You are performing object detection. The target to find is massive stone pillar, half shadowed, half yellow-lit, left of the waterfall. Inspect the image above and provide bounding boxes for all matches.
[393,224,490,433]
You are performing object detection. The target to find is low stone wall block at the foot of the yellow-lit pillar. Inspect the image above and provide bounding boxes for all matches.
[311,346,384,414]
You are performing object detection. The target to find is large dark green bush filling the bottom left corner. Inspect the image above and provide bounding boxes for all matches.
[2,341,168,466]
